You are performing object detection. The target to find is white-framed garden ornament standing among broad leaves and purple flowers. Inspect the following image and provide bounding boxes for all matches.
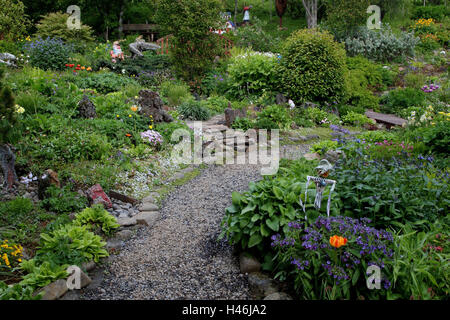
[299,159,336,220]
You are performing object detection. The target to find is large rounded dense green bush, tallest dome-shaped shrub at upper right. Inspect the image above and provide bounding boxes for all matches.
[277,29,346,103]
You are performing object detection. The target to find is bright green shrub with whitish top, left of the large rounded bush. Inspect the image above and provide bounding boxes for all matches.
[228,51,278,98]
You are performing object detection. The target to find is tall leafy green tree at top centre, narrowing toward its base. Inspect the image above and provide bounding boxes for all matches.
[155,0,224,79]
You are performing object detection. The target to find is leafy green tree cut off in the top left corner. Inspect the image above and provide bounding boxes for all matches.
[0,0,29,40]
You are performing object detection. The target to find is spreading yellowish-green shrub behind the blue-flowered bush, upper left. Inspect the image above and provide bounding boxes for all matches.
[36,12,94,42]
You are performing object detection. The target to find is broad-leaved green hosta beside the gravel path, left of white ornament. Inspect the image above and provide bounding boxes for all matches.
[220,159,336,269]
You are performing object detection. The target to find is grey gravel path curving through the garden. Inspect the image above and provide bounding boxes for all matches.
[80,165,261,300]
